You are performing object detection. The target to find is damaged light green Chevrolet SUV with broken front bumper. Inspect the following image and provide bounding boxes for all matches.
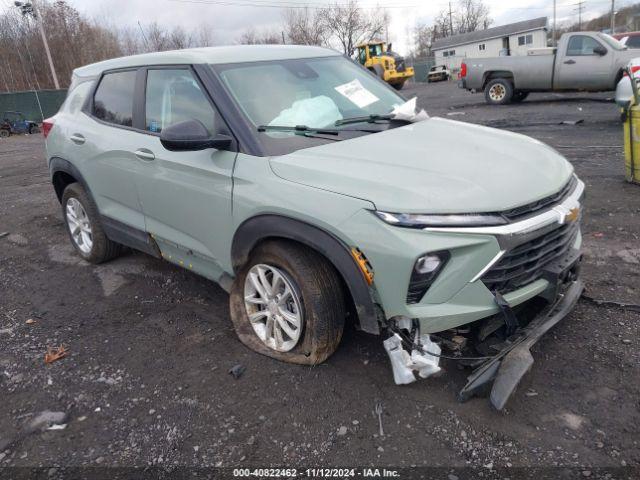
[44,46,584,407]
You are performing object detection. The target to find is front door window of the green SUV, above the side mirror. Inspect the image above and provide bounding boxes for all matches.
[145,69,216,134]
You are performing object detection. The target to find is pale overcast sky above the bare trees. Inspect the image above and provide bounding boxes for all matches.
[51,0,634,54]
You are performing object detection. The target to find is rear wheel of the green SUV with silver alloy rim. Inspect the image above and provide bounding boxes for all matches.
[62,183,122,264]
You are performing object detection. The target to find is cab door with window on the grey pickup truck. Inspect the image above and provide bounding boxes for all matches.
[555,34,614,90]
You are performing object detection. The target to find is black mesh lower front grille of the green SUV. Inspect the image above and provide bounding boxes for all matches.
[482,222,580,294]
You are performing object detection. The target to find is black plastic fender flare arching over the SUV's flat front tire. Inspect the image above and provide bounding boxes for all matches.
[231,214,380,335]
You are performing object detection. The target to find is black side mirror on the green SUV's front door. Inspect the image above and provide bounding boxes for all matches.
[160,120,233,152]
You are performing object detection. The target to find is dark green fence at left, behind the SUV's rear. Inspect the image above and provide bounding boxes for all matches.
[0,90,67,122]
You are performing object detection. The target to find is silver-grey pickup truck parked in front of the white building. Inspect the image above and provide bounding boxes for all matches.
[459,32,638,105]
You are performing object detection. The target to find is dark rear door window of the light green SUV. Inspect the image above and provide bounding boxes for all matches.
[93,70,136,127]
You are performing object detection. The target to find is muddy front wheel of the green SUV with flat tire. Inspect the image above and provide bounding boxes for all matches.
[229,241,346,365]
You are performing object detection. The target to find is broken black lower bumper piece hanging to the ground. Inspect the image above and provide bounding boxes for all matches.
[458,280,584,410]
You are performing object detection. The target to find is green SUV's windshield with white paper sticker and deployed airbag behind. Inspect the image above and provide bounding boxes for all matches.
[214,56,404,128]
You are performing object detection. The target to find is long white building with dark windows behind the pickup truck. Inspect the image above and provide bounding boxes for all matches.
[431,17,547,71]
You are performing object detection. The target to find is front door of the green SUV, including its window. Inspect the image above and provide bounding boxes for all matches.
[137,67,237,280]
